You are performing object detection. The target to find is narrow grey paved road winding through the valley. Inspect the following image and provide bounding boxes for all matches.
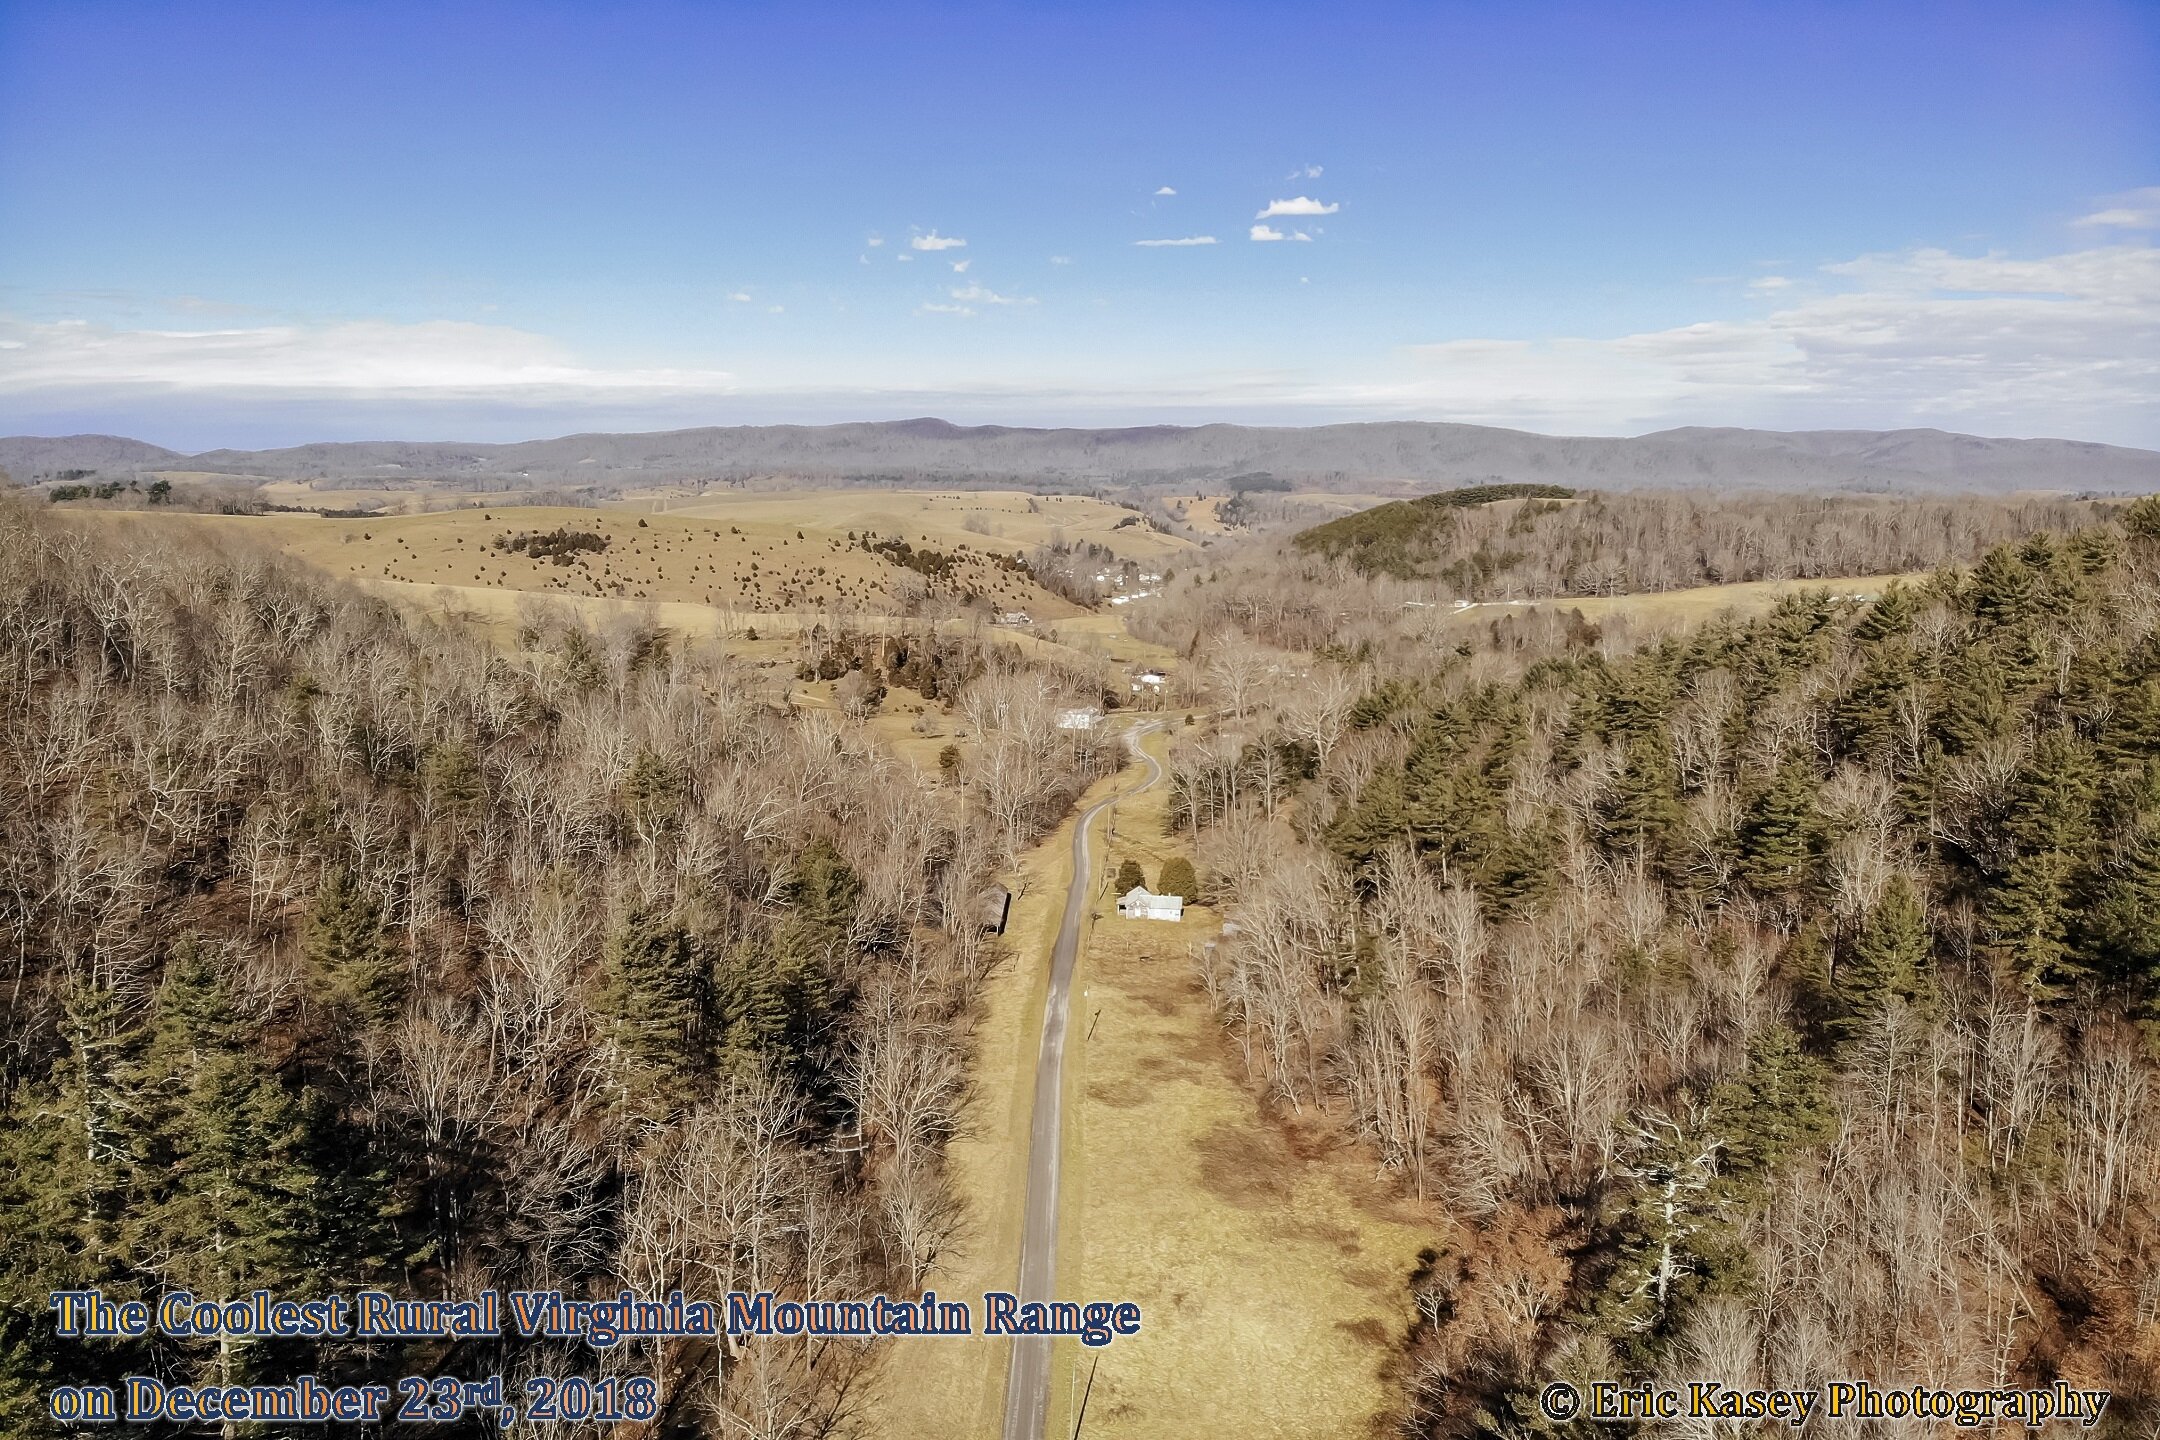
[1004,725,1162,1440]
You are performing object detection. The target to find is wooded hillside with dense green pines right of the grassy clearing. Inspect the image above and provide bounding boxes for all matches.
[1173,501,2160,1436]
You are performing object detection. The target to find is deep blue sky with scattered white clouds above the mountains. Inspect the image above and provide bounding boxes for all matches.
[0,0,2160,449]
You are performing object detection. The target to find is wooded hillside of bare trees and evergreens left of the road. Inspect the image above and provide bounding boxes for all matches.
[0,501,1119,1436]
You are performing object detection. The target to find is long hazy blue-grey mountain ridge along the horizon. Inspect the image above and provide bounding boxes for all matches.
[0,419,2160,492]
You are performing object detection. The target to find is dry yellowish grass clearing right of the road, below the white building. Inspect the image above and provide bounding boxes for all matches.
[1050,738,1441,1440]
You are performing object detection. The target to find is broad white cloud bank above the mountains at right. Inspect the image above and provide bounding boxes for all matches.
[1367,244,2160,436]
